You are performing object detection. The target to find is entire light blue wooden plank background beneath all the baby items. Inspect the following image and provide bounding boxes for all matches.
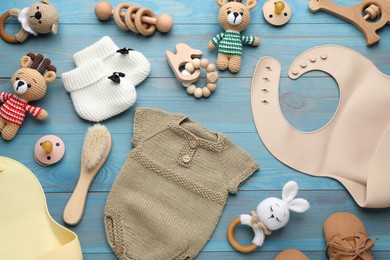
[0,0,390,260]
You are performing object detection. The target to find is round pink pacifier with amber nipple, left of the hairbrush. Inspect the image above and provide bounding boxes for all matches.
[34,135,65,166]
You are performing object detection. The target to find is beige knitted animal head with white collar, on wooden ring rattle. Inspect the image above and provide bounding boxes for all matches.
[10,0,59,42]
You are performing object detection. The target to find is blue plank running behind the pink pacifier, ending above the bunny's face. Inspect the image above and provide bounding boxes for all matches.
[0,133,343,192]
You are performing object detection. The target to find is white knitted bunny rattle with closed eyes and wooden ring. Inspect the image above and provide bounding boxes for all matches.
[228,181,310,253]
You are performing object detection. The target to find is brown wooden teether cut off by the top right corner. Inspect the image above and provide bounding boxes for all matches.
[309,0,390,46]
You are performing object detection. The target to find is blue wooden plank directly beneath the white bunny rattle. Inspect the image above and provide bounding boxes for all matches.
[46,190,390,259]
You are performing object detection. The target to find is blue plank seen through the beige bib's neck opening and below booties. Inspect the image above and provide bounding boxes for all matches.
[0,78,338,135]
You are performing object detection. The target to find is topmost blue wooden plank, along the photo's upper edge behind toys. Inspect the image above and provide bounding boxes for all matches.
[1,0,366,26]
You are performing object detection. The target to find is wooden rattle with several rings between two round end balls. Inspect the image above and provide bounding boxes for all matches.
[95,1,173,36]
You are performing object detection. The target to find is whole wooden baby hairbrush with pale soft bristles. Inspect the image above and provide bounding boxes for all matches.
[63,124,112,226]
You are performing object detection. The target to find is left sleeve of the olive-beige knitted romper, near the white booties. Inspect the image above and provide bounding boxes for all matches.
[132,108,183,147]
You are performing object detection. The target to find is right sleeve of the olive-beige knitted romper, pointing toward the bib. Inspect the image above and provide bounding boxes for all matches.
[222,140,260,194]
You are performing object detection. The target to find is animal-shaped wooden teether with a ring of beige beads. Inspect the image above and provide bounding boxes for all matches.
[165,43,218,98]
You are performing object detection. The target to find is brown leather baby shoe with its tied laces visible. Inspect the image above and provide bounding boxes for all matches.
[324,212,375,260]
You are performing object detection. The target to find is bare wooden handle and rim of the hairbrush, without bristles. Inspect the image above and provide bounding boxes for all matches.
[62,137,112,226]
